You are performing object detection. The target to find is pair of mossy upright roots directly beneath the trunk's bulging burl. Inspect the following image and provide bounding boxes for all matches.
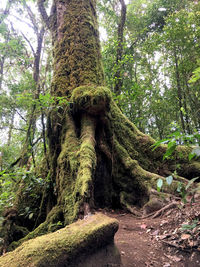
[56,114,96,225]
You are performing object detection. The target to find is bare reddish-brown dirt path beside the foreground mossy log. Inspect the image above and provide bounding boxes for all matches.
[105,212,200,267]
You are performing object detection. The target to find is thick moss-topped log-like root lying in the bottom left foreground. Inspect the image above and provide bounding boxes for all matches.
[0,213,118,267]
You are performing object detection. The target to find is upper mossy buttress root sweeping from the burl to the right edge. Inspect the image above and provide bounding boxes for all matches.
[109,101,200,178]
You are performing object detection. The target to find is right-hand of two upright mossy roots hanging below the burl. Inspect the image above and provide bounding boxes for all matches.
[75,114,96,215]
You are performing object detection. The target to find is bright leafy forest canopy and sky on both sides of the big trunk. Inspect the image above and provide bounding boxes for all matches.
[0,0,200,169]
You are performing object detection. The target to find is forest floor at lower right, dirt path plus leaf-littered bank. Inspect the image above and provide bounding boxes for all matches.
[103,199,200,267]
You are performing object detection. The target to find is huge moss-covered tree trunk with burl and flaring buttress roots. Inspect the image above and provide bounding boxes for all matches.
[1,0,200,253]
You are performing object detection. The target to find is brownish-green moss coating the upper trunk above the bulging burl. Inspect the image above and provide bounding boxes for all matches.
[52,0,104,96]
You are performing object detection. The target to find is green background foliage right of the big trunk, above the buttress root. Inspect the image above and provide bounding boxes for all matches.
[100,0,200,138]
